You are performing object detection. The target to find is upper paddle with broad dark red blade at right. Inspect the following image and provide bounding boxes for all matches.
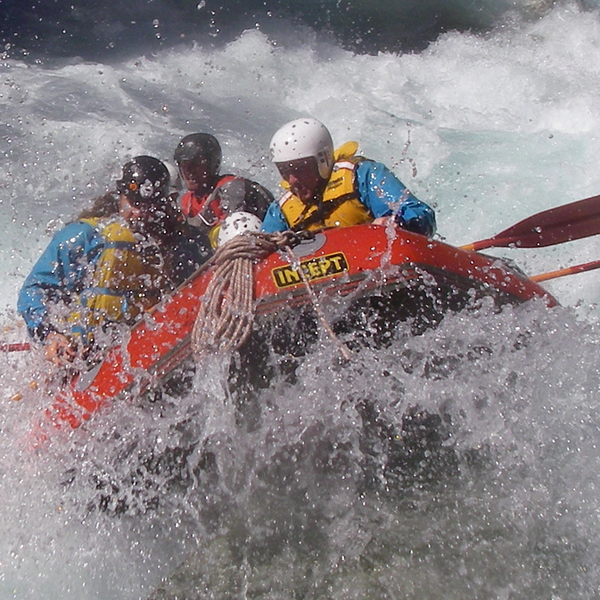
[460,196,600,250]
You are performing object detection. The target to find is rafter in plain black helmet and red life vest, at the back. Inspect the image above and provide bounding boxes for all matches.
[174,133,273,248]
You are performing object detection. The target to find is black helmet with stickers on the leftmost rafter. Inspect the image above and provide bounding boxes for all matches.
[117,156,170,202]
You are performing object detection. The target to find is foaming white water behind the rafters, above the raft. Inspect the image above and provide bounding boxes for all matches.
[0,8,600,318]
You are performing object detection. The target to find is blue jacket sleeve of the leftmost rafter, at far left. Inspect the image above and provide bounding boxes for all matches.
[17,222,103,340]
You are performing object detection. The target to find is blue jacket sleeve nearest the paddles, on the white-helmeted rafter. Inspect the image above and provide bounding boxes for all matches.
[356,160,436,237]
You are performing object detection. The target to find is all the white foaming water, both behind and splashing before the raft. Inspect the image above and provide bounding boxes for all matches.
[0,5,600,600]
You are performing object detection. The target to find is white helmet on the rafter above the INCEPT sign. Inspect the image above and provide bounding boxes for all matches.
[270,118,333,179]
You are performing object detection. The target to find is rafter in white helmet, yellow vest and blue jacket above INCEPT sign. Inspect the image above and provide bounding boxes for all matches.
[262,118,436,237]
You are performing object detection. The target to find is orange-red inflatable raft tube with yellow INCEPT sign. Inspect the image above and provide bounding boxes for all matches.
[41,225,557,428]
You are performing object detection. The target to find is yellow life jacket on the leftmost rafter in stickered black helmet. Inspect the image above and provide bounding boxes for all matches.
[81,218,166,327]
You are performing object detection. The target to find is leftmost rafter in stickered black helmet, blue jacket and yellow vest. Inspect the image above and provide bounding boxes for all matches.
[17,156,185,365]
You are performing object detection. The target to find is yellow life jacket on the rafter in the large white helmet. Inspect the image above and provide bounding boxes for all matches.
[279,142,373,231]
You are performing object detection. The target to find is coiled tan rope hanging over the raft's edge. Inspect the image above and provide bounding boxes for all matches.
[192,231,301,359]
